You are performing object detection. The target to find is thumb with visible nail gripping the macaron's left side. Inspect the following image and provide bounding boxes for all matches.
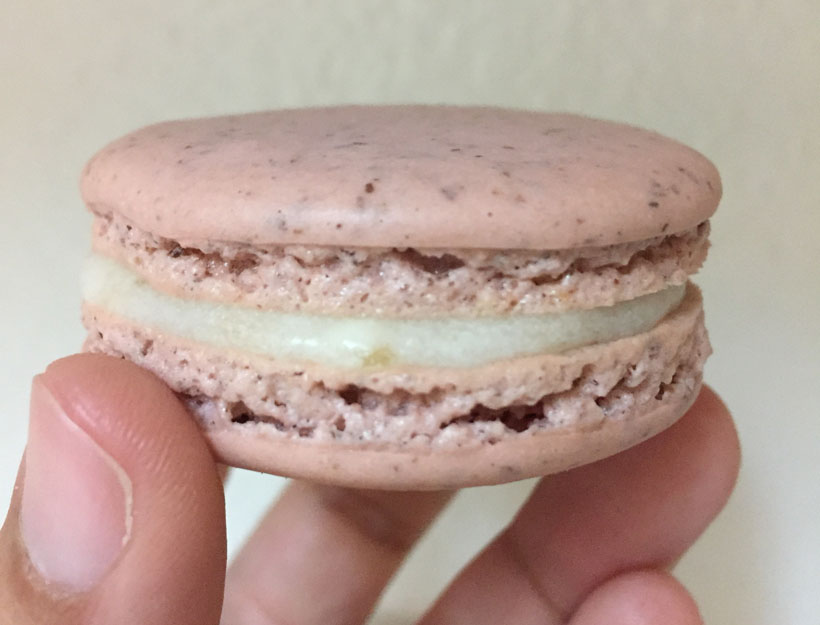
[0,354,226,625]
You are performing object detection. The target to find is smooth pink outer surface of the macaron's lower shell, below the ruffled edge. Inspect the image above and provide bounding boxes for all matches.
[211,388,700,491]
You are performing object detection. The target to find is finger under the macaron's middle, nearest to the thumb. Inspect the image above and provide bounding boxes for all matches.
[222,482,451,625]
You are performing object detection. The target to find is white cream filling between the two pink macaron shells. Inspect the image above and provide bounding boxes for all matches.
[82,254,686,367]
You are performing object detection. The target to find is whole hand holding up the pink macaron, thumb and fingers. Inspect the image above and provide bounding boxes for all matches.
[0,355,739,625]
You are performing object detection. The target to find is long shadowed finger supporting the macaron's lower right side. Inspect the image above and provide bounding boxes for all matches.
[421,389,739,625]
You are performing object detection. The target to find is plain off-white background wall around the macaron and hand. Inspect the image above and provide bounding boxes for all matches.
[0,0,820,625]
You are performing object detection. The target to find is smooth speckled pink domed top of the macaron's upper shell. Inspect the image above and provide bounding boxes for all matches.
[82,106,721,249]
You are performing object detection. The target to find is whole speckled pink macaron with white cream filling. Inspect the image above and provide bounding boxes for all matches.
[81,106,721,490]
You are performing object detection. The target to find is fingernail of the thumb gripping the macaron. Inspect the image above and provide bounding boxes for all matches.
[20,377,131,592]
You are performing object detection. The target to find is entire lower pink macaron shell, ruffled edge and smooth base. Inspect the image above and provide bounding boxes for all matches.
[85,285,710,490]
